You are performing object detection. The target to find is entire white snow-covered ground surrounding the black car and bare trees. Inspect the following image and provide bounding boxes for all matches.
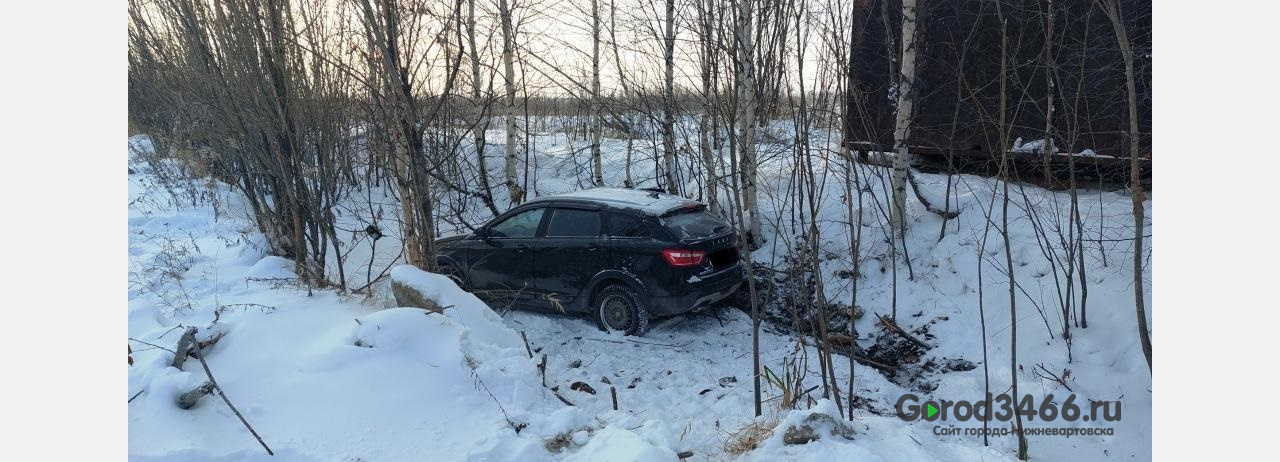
[128,120,1152,461]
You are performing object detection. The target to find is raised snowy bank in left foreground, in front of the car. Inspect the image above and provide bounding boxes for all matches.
[128,150,564,461]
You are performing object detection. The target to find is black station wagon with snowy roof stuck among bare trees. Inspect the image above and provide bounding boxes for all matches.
[438,188,745,335]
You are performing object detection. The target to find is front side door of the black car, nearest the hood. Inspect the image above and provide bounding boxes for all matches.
[468,207,548,306]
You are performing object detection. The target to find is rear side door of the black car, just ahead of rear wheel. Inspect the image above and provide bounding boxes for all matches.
[534,206,609,311]
